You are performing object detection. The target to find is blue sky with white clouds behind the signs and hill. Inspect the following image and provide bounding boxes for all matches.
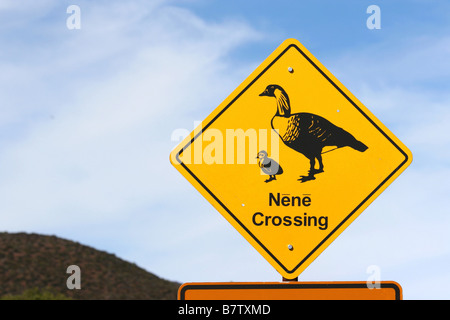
[0,0,450,299]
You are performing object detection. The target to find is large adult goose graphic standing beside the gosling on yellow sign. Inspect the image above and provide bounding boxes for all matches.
[260,84,367,182]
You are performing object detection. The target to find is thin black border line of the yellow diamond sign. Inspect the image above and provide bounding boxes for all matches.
[176,44,408,274]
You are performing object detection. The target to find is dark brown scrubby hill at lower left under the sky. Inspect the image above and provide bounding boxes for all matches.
[0,232,180,300]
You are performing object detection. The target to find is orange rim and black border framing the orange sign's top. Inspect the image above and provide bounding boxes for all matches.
[179,281,401,300]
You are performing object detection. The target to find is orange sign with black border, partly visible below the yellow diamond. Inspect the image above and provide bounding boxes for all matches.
[178,281,403,300]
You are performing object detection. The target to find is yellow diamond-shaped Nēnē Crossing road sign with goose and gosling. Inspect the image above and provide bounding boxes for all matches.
[171,39,412,279]
